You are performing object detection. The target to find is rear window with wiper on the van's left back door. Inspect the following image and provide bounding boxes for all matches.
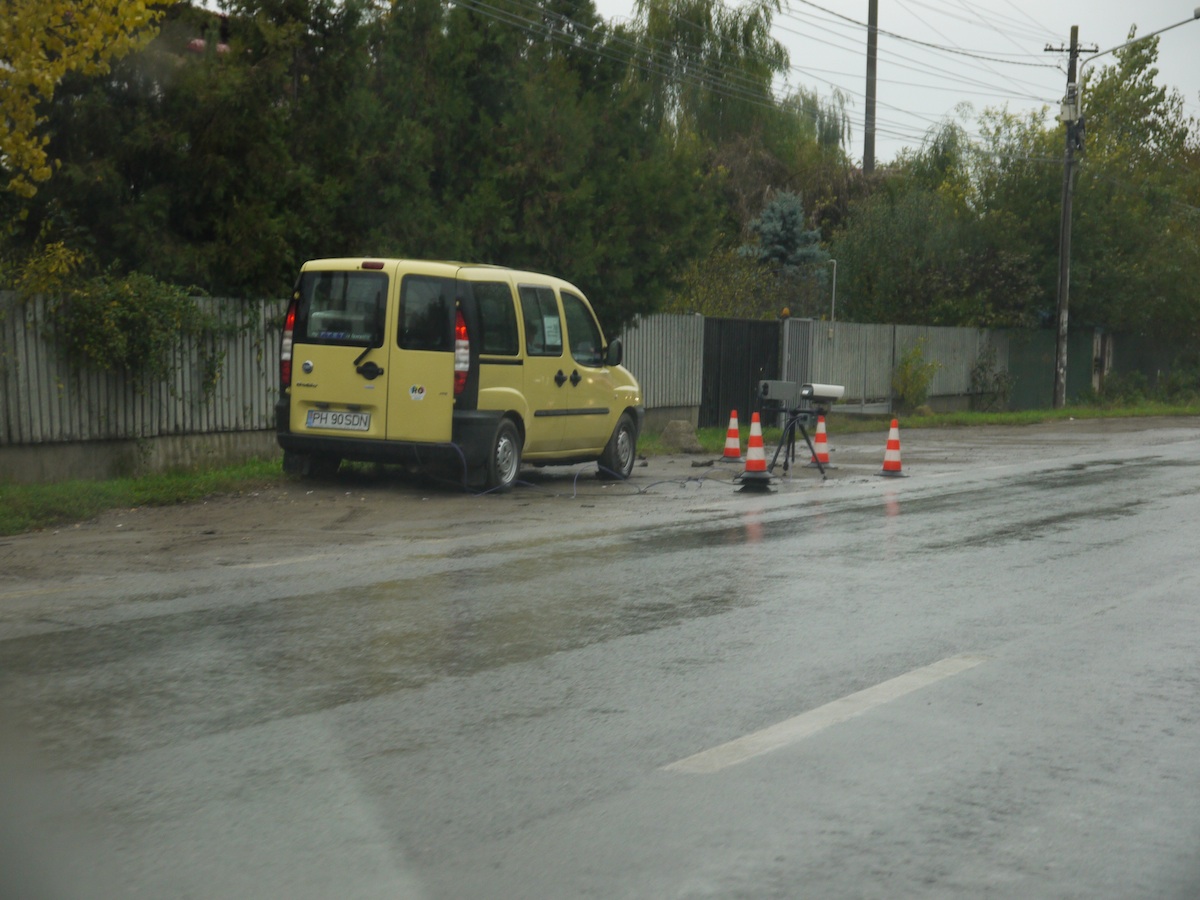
[295,272,388,347]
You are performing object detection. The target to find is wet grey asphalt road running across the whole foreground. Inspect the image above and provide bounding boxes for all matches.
[0,419,1200,900]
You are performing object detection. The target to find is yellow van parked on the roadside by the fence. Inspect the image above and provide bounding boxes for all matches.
[276,259,646,490]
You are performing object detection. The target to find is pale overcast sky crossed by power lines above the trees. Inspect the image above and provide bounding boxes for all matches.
[596,0,1200,162]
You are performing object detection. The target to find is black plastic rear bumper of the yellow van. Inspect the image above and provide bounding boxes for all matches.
[275,403,502,468]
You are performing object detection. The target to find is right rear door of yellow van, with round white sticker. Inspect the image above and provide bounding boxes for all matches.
[388,273,457,443]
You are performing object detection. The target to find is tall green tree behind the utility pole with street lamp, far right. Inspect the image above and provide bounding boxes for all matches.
[974,34,1200,341]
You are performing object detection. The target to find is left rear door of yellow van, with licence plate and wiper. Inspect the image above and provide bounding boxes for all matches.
[289,260,390,438]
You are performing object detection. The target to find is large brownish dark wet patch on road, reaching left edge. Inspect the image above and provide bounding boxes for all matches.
[0,549,744,766]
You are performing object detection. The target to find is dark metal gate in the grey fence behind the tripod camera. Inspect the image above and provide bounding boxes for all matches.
[700,319,780,428]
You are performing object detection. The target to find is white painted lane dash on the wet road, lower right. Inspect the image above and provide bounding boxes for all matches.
[662,653,988,775]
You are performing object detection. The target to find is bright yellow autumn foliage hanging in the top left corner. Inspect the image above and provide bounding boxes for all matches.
[0,0,178,198]
